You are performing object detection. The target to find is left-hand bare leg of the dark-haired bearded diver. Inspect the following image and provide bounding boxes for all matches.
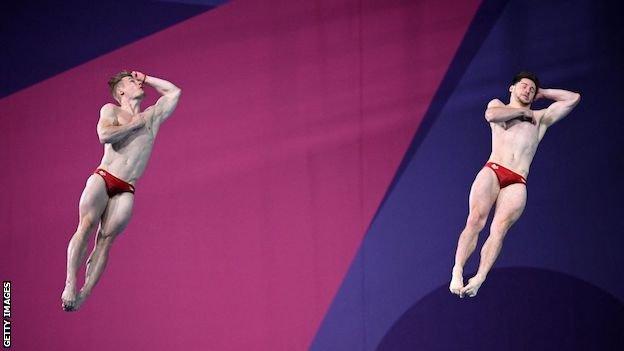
[449,167,500,297]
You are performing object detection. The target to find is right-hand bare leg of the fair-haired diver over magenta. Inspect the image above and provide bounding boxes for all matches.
[76,193,134,308]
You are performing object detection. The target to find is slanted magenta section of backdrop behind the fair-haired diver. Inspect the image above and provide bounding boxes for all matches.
[0,1,478,351]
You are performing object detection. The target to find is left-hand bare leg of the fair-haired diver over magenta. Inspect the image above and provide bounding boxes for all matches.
[61,174,108,311]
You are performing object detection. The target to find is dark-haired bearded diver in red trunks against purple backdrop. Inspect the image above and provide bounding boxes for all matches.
[449,72,580,297]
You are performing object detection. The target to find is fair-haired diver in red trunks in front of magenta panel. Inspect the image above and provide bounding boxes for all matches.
[61,71,181,311]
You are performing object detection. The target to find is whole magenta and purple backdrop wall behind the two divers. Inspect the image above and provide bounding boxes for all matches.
[0,0,624,350]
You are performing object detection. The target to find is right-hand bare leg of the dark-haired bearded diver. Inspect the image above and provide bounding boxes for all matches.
[461,184,527,297]
